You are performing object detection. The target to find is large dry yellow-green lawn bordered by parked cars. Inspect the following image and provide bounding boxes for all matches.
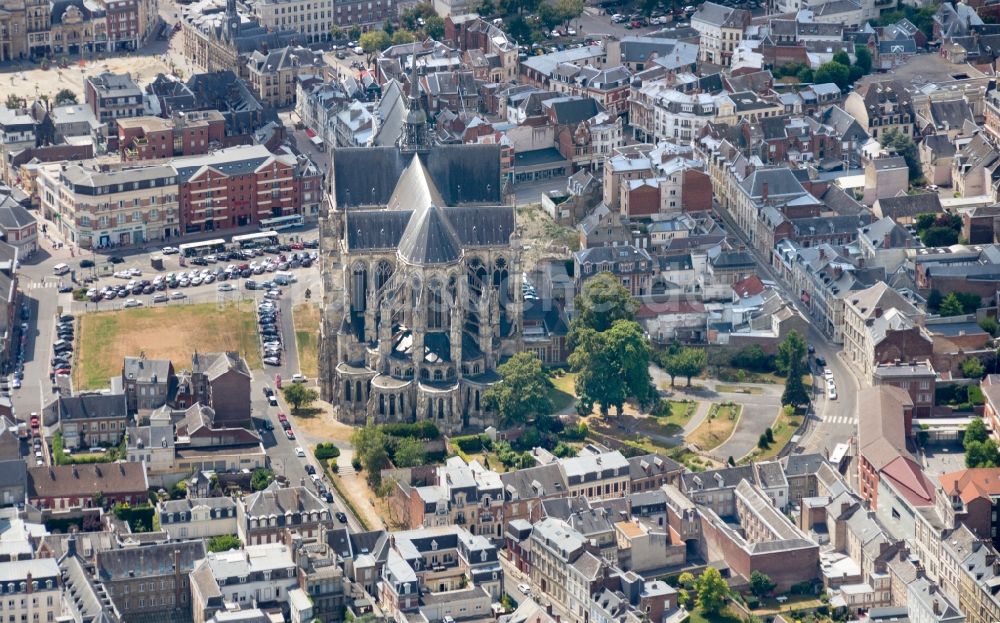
[73,303,261,390]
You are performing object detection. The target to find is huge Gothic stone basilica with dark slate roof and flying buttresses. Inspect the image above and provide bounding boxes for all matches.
[320,99,523,433]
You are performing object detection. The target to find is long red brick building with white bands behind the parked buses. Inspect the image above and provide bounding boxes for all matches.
[173,145,322,233]
